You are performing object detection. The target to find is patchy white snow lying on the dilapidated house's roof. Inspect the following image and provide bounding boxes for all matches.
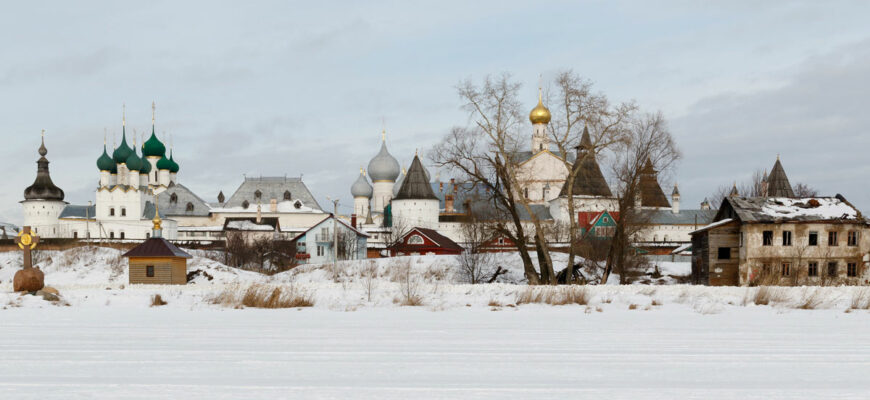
[761,197,858,219]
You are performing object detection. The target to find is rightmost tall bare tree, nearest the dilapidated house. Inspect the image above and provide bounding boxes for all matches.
[601,113,680,283]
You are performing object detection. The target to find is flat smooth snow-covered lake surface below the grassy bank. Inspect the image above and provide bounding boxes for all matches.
[0,304,870,399]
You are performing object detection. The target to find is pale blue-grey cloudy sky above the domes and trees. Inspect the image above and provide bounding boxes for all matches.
[0,0,870,223]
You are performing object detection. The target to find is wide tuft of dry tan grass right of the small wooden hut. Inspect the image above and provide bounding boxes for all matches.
[210,283,314,308]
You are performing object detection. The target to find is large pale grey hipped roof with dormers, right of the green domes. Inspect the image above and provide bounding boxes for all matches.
[224,176,323,211]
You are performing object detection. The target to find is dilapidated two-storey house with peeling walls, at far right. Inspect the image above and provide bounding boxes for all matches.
[692,195,870,285]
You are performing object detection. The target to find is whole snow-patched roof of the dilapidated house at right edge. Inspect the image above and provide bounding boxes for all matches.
[714,195,864,223]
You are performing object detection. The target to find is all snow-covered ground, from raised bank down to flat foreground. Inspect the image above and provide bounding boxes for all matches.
[0,249,870,399]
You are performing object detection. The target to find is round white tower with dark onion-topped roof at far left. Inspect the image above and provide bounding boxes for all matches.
[21,130,67,238]
